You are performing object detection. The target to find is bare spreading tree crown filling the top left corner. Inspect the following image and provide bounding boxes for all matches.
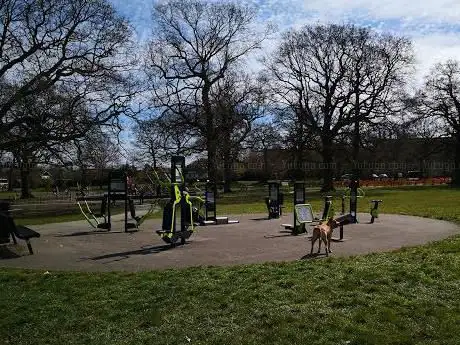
[0,0,134,150]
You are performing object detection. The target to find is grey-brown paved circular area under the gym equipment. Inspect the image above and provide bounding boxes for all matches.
[0,214,460,271]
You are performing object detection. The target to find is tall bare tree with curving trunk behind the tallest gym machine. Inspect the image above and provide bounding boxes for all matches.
[147,0,267,180]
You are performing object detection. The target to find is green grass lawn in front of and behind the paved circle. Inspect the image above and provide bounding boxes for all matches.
[0,187,460,345]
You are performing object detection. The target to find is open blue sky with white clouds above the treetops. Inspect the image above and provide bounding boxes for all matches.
[110,0,460,81]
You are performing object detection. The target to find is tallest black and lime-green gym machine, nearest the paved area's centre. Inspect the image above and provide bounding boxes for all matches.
[157,156,194,246]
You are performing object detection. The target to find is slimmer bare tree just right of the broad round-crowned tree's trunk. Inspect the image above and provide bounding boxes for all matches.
[347,26,414,167]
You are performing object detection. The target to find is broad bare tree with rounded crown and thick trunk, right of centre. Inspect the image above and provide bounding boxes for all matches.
[267,25,411,191]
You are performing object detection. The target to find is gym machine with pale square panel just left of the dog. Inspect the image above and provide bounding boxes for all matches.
[281,182,314,235]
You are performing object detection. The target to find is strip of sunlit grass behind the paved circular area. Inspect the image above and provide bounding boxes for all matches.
[17,186,460,225]
